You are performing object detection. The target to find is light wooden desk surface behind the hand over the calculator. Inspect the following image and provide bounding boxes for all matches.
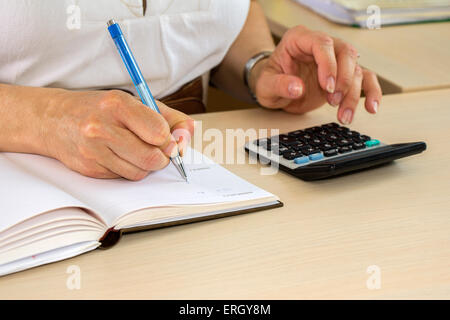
[259,0,450,93]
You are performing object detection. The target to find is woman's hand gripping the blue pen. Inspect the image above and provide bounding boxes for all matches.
[41,90,194,180]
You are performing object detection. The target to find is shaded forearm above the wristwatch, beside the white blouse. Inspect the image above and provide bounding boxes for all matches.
[211,0,275,101]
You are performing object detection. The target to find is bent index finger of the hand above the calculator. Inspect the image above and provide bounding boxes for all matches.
[283,27,337,93]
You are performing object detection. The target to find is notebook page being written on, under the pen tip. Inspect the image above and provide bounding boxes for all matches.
[8,149,272,227]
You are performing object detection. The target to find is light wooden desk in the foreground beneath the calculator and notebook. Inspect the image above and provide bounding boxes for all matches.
[0,90,450,299]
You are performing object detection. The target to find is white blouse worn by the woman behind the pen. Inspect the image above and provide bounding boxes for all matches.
[0,0,250,98]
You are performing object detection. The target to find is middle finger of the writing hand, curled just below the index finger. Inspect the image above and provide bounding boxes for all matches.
[106,127,169,172]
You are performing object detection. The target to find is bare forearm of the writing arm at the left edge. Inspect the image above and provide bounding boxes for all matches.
[0,84,61,155]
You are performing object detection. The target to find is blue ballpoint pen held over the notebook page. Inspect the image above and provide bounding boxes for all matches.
[107,19,188,181]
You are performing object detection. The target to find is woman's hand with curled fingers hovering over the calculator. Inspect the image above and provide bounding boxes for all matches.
[250,26,382,124]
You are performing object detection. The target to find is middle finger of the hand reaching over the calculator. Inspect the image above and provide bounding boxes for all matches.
[328,39,358,106]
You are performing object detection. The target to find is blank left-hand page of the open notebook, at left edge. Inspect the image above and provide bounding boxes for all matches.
[0,153,90,232]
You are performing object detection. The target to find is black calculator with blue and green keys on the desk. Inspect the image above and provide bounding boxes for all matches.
[245,122,426,181]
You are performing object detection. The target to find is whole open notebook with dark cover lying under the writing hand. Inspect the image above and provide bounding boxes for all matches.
[0,149,282,275]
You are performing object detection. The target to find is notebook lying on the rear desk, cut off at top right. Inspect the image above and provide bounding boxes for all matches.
[295,0,450,28]
